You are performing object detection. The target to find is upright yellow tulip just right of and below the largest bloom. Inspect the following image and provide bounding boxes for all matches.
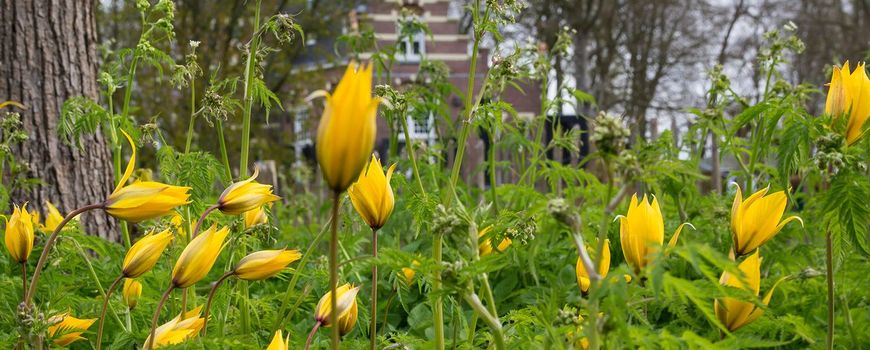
[347,155,396,230]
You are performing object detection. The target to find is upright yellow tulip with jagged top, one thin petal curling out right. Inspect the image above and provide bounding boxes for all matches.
[617,193,691,273]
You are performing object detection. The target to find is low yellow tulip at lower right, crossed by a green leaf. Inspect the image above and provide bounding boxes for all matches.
[713,250,785,332]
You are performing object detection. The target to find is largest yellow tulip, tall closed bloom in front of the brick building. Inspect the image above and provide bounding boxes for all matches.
[315,62,380,192]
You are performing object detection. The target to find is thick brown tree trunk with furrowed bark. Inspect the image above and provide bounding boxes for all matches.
[0,0,120,241]
